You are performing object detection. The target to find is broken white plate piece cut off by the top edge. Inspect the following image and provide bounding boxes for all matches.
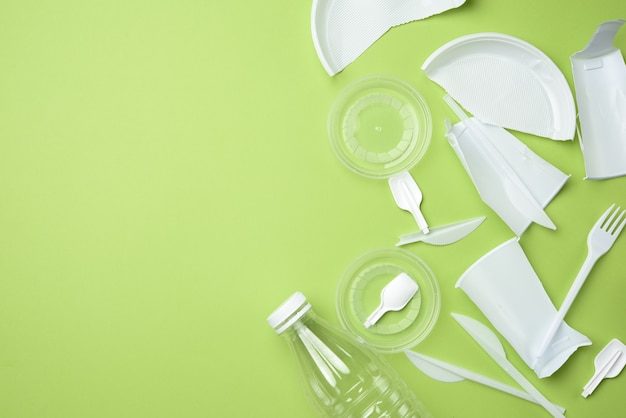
[311,0,465,76]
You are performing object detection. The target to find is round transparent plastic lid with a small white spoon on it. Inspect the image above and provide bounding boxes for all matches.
[336,247,441,353]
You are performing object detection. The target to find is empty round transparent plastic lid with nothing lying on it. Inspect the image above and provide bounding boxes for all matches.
[328,75,432,178]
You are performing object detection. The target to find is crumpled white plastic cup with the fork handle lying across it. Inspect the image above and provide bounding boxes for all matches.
[456,239,591,378]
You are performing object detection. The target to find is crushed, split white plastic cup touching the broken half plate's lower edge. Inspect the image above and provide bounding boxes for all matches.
[444,96,569,237]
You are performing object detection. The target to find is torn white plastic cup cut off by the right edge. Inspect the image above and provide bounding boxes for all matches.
[570,20,626,179]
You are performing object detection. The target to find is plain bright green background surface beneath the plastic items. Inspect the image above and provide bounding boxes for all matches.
[0,0,626,418]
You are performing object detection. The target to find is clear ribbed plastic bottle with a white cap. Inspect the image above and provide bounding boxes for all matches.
[267,292,432,418]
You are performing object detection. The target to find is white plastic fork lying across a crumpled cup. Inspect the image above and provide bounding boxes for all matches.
[535,204,626,364]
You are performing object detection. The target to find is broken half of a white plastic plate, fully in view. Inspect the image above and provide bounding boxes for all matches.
[422,33,576,140]
